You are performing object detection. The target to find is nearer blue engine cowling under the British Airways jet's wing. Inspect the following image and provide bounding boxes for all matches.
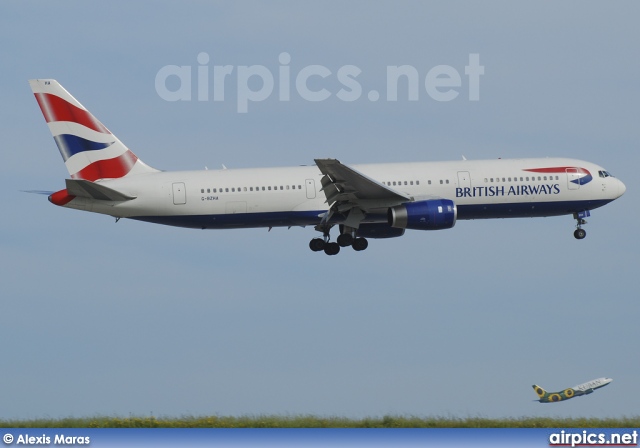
[387,199,458,230]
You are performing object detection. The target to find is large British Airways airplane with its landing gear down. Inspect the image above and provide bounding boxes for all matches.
[29,79,626,255]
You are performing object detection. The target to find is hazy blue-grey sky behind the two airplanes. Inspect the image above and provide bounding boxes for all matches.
[0,1,640,419]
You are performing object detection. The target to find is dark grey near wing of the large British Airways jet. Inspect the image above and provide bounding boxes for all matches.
[315,159,413,213]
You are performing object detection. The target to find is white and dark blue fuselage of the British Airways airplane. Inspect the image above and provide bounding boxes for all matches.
[66,158,625,228]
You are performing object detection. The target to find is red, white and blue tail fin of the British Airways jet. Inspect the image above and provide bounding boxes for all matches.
[29,79,157,182]
